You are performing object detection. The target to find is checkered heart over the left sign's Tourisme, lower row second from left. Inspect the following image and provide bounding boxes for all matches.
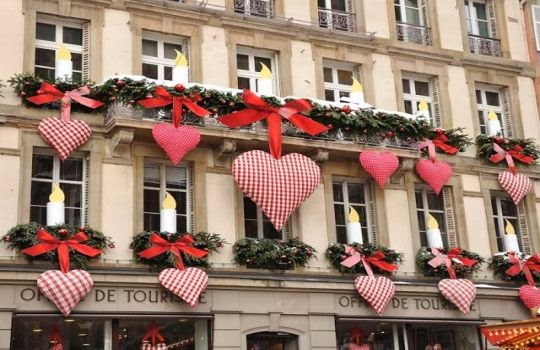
[159,267,208,307]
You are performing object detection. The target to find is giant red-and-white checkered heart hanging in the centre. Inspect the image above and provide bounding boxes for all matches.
[232,151,321,231]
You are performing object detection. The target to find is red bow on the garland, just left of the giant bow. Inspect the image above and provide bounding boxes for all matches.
[139,86,210,127]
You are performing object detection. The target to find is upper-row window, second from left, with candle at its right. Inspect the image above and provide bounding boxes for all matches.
[142,32,189,80]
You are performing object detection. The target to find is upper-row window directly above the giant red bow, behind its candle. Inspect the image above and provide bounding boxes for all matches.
[236,47,278,95]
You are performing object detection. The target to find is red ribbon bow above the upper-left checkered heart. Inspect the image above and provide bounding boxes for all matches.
[27,83,103,122]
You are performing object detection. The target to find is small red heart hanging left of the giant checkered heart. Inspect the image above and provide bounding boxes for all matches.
[152,123,201,165]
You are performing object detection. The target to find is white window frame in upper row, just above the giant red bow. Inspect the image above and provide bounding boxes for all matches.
[236,46,279,96]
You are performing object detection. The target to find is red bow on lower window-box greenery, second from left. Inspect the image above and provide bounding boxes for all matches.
[139,233,208,270]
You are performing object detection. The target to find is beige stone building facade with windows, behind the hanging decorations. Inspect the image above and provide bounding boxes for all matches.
[0,0,540,350]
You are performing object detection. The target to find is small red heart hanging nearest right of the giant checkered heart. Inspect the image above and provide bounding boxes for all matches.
[359,151,399,188]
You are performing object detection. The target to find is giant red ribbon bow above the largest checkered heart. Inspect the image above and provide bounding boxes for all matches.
[218,90,327,159]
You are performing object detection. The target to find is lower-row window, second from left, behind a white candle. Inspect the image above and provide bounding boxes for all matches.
[143,163,193,232]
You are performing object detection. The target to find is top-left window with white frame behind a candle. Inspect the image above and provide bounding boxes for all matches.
[34,19,86,82]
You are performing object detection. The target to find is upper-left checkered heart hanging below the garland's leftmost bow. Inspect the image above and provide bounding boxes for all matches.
[38,118,92,160]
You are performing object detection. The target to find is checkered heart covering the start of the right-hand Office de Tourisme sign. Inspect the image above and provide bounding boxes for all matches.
[354,276,396,316]
